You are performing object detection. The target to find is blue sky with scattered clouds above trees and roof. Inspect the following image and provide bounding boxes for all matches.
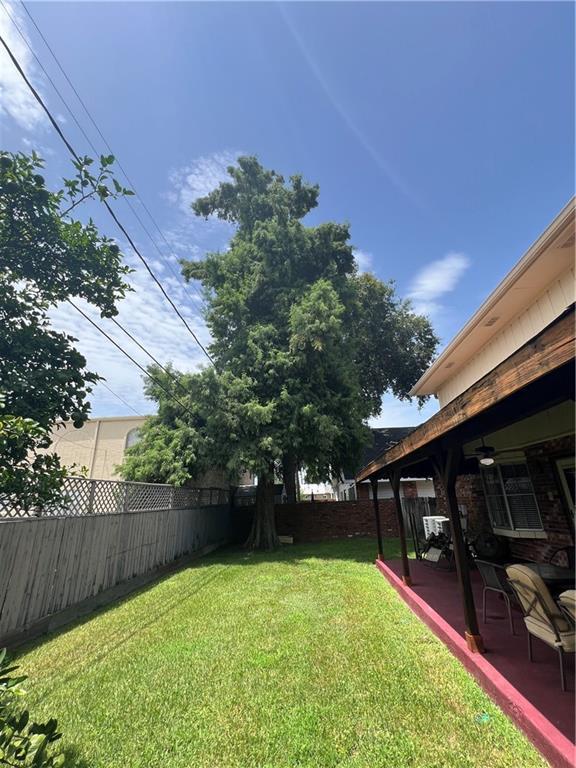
[0,2,574,426]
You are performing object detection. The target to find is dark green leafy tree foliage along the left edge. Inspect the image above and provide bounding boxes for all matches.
[0,152,130,504]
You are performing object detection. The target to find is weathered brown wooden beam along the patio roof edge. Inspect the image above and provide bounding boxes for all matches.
[356,307,576,481]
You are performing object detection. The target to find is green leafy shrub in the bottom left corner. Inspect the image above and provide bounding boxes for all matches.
[0,649,65,768]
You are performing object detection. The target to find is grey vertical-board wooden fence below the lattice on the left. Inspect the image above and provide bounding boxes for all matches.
[0,505,231,646]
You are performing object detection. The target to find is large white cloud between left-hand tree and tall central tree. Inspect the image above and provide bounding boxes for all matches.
[51,152,245,416]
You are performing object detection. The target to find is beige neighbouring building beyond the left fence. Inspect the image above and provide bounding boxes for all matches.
[50,416,146,480]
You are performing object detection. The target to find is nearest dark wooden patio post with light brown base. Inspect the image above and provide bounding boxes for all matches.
[432,446,484,653]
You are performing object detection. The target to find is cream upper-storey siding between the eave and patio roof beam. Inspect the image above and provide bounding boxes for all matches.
[437,268,576,408]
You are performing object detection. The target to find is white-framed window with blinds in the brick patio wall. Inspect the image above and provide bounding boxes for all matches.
[481,463,543,537]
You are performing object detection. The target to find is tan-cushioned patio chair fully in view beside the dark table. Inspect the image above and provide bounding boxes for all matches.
[506,565,576,691]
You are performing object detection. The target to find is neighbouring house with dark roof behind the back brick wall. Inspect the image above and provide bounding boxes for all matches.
[332,427,435,501]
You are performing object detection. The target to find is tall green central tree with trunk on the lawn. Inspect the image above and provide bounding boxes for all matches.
[123,157,437,547]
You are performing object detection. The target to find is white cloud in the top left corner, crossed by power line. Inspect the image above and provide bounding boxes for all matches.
[0,1,45,131]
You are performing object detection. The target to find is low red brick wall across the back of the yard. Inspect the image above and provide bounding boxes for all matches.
[276,499,398,542]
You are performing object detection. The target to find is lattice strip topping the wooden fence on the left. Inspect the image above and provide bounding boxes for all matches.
[0,477,230,518]
